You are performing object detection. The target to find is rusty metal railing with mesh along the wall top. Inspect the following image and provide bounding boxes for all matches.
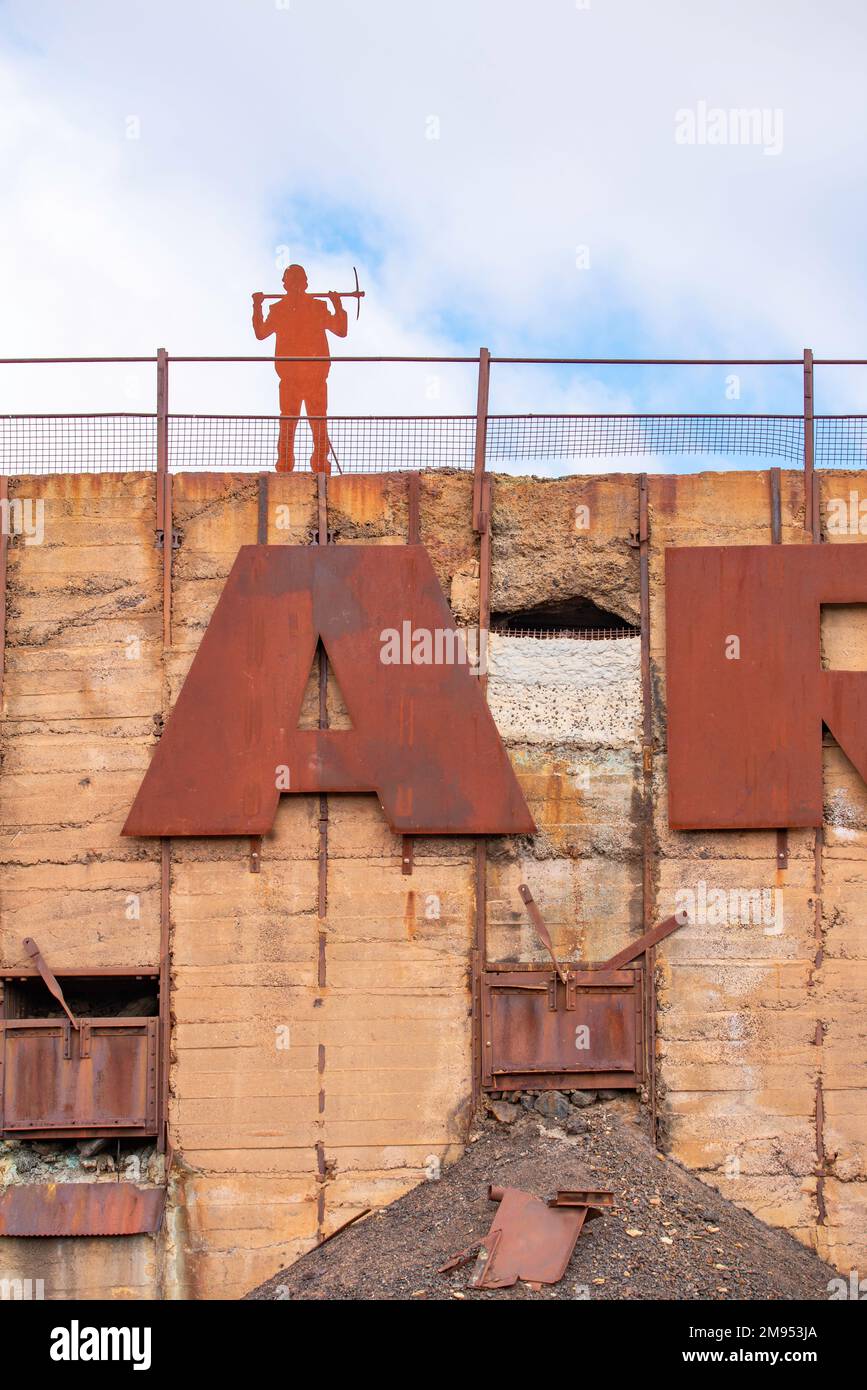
[0,348,867,533]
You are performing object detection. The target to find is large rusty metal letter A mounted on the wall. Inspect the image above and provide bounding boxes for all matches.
[124,545,535,835]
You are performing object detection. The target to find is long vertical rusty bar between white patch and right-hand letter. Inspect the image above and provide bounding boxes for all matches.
[638,473,659,1144]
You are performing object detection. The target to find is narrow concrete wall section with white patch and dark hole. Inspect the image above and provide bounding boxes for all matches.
[488,474,642,962]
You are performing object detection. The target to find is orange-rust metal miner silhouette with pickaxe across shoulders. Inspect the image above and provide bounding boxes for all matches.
[253,265,364,473]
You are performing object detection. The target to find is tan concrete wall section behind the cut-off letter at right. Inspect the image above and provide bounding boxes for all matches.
[650,473,867,1269]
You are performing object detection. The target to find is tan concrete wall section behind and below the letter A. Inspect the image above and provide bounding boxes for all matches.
[161,475,472,1297]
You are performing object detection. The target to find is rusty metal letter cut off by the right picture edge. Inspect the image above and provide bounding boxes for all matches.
[666,545,867,830]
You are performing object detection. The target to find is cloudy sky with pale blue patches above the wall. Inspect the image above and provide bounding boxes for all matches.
[0,0,867,471]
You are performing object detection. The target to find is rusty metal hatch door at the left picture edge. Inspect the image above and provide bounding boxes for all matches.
[0,1017,158,1138]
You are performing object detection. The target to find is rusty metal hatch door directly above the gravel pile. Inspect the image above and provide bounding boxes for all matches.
[482,967,643,1091]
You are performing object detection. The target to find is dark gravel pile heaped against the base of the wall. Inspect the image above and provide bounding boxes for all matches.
[247,1093,835,1301]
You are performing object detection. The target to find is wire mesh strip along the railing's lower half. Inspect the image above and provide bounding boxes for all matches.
[0,414,867,474]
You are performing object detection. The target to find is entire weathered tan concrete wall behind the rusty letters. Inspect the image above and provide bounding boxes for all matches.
[0,474,867,1297]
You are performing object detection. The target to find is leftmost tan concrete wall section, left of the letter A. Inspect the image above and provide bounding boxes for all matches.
[0,475,163,1298]
